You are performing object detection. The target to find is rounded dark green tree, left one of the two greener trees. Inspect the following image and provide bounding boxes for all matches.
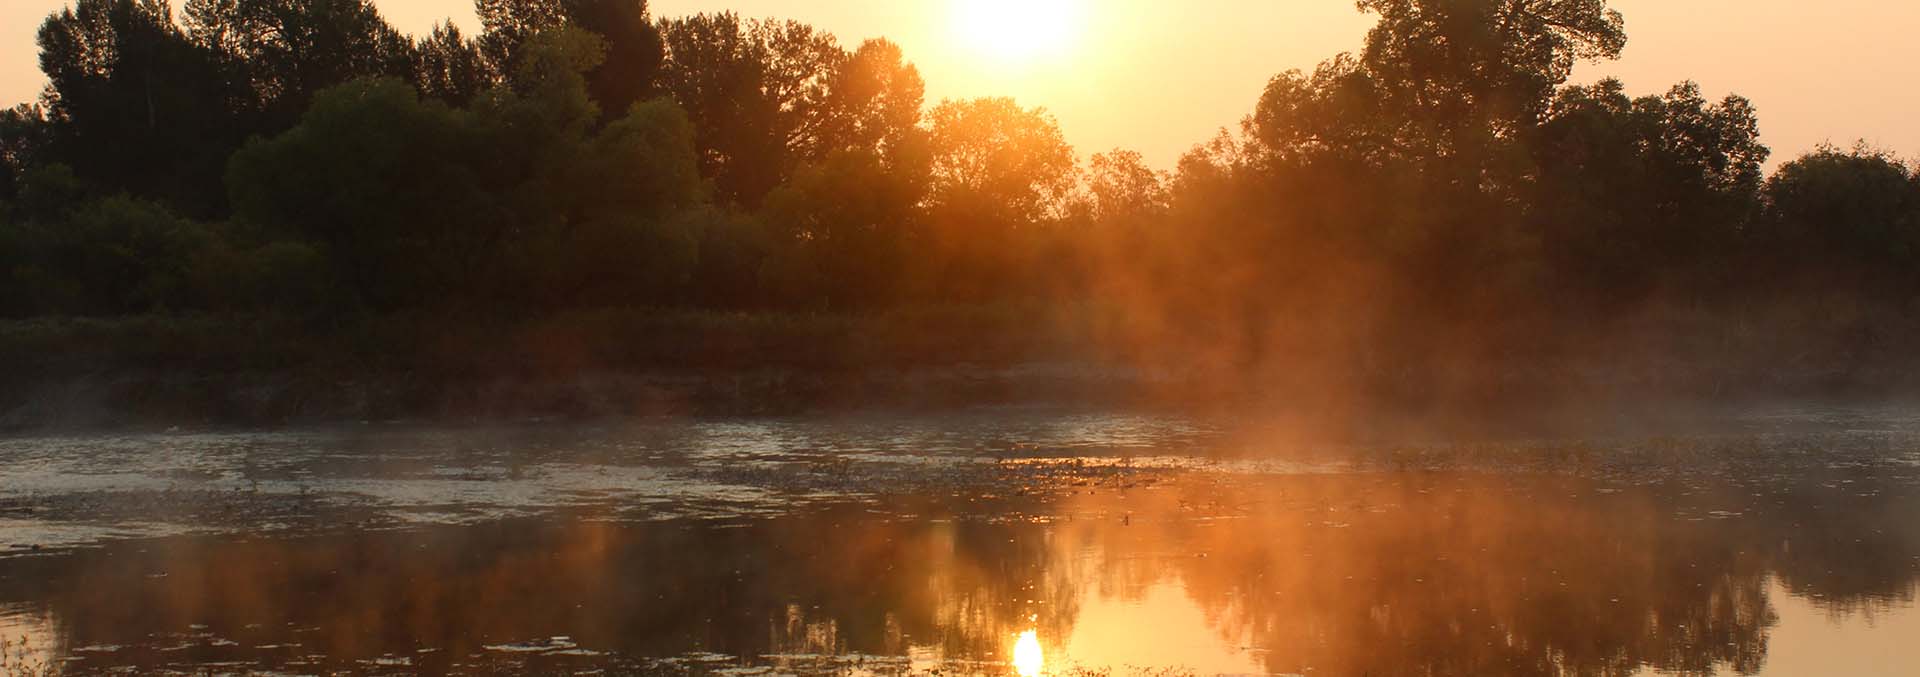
[227,79,487,309]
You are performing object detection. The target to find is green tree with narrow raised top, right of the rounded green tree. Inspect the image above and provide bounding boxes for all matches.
[474,27,705,309]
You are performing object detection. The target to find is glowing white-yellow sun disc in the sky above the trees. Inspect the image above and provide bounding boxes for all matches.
[948,0,1087,63]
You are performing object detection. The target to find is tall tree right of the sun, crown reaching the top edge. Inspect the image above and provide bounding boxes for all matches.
[1221,0,1643,326]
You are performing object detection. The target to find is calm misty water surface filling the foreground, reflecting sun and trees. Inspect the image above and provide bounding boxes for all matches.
[0,407,1920,675]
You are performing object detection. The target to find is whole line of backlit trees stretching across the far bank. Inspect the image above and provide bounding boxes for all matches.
[0,0,1920,364]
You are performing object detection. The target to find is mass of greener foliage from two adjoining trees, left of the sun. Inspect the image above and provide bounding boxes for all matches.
[228,29,703,311]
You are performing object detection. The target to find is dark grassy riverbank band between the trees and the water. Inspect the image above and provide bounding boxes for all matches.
[0,307,1920,432]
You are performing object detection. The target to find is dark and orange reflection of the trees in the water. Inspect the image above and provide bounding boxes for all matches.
[0,472,1920,675]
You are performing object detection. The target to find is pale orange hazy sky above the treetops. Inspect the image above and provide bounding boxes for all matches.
[0,0,1920,165]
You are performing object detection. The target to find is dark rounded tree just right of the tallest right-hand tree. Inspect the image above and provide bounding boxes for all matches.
[1526,81,1768,303]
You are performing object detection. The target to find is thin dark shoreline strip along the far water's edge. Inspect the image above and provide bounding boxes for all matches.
[0,362,1920,433]
